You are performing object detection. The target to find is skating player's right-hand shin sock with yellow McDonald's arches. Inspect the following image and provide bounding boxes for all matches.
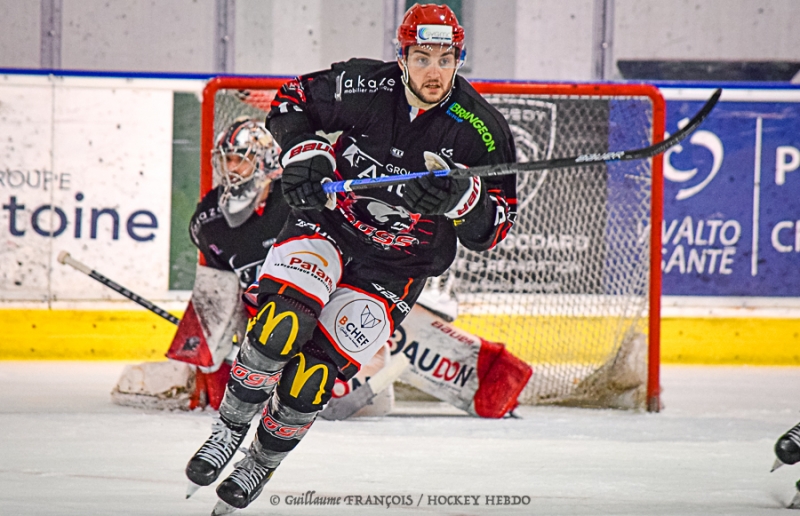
[257,345,337,468]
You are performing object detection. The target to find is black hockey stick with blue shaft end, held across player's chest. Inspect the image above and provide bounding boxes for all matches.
[322,89,722,194]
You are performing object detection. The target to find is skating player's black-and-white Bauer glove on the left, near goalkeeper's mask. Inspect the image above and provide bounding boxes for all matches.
[281,135,336,210]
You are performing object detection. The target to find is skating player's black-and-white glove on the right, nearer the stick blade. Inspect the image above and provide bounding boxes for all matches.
[403,151,481,219]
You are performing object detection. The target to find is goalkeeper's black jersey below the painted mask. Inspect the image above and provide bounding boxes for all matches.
[189,181,290,288]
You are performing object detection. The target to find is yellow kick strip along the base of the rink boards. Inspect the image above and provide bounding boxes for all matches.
[0,309,800,366]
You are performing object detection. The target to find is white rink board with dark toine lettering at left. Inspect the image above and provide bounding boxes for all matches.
[0,75,203,305]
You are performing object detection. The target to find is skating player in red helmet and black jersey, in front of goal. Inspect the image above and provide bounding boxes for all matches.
[192,4,515,514]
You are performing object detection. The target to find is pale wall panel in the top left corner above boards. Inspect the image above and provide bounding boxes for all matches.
[0,0,41,68]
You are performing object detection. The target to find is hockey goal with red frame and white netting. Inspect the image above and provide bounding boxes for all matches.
[201,77,664,411]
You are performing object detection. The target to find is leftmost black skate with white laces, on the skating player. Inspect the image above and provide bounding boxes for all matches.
[186,417,250,498]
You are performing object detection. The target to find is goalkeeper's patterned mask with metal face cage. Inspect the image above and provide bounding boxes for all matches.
[211,119,282,228]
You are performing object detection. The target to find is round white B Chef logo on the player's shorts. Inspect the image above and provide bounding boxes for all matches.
[335,299,386,353]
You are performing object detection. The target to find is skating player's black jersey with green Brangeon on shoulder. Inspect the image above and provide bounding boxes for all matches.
[267,59,516,276]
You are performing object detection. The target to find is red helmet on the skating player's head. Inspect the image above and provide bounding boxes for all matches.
[397,4,465,61]
